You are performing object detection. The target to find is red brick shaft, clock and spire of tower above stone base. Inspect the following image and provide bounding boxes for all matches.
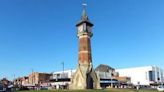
[76,5,93,65]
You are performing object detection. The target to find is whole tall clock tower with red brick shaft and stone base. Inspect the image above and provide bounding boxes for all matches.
[70,4,100,89]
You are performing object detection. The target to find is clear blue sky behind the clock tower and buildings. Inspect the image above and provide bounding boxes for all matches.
[0,0,164,79]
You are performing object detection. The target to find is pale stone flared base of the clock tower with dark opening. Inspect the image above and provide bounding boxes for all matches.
[69,65,101,89]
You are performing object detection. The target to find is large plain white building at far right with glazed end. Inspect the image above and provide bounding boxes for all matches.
[116,66,163,85]
